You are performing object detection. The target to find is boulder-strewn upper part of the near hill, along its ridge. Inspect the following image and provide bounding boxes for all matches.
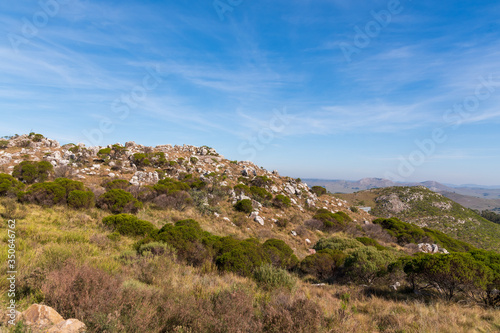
[0,133,374,255]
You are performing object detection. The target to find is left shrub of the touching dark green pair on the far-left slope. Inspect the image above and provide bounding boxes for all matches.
[18,182,66,206]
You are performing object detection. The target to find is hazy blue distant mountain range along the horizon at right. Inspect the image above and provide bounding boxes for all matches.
[304,178,500,211]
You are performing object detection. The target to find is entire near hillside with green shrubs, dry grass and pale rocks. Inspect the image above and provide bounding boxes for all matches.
[0,133,500,332]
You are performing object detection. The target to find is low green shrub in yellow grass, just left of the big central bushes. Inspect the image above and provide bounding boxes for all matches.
[102,214,158,236]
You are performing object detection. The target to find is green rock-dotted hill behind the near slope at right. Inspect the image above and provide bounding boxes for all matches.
[336,186,500,250]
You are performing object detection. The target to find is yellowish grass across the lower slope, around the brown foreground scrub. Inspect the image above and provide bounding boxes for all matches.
[0,198,500,332]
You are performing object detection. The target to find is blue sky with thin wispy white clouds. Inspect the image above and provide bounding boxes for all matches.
[0,0,500,185]
